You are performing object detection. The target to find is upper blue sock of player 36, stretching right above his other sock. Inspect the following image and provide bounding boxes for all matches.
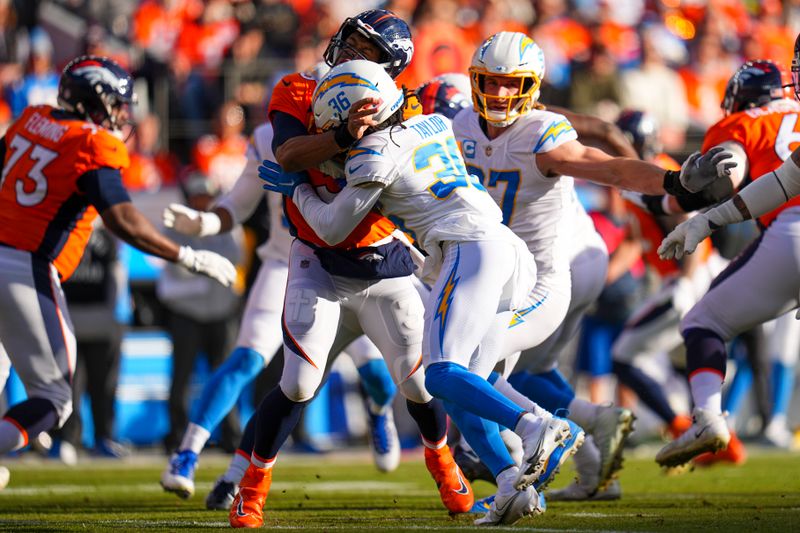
[425,361,525,429]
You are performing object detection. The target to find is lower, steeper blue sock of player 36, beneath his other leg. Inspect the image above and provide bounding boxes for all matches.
[444,402,514,477]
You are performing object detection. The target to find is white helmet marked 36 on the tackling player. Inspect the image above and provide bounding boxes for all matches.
[312,59,405,131]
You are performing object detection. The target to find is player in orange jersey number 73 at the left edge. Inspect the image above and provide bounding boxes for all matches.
[0,56,236,478]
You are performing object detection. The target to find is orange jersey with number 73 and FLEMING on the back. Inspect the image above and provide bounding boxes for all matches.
[0,106,129,279]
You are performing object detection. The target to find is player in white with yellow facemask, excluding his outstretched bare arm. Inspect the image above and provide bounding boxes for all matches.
[453,32,644,493]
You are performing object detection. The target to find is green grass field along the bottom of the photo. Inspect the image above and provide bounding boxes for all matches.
[0,451,800,532]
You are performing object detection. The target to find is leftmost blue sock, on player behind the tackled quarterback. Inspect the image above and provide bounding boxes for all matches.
[191,346,265,431]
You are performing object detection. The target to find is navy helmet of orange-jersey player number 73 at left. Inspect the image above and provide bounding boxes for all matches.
[58,56,136,130]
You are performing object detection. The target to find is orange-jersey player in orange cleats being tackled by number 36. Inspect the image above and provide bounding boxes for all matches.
[229,10,473,527]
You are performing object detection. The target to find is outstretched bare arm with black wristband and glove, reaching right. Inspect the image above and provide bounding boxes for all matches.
[536,141,736,196]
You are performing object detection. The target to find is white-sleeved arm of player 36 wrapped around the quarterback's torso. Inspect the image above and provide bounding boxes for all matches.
[292,184,383,246]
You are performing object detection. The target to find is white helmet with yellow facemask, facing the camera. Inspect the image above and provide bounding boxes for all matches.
[469,31,544,127]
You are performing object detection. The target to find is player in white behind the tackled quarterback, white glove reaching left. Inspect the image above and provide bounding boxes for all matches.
[161,118,400,509]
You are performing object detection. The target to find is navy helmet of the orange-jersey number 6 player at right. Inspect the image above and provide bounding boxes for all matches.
[722,60,784,115]
